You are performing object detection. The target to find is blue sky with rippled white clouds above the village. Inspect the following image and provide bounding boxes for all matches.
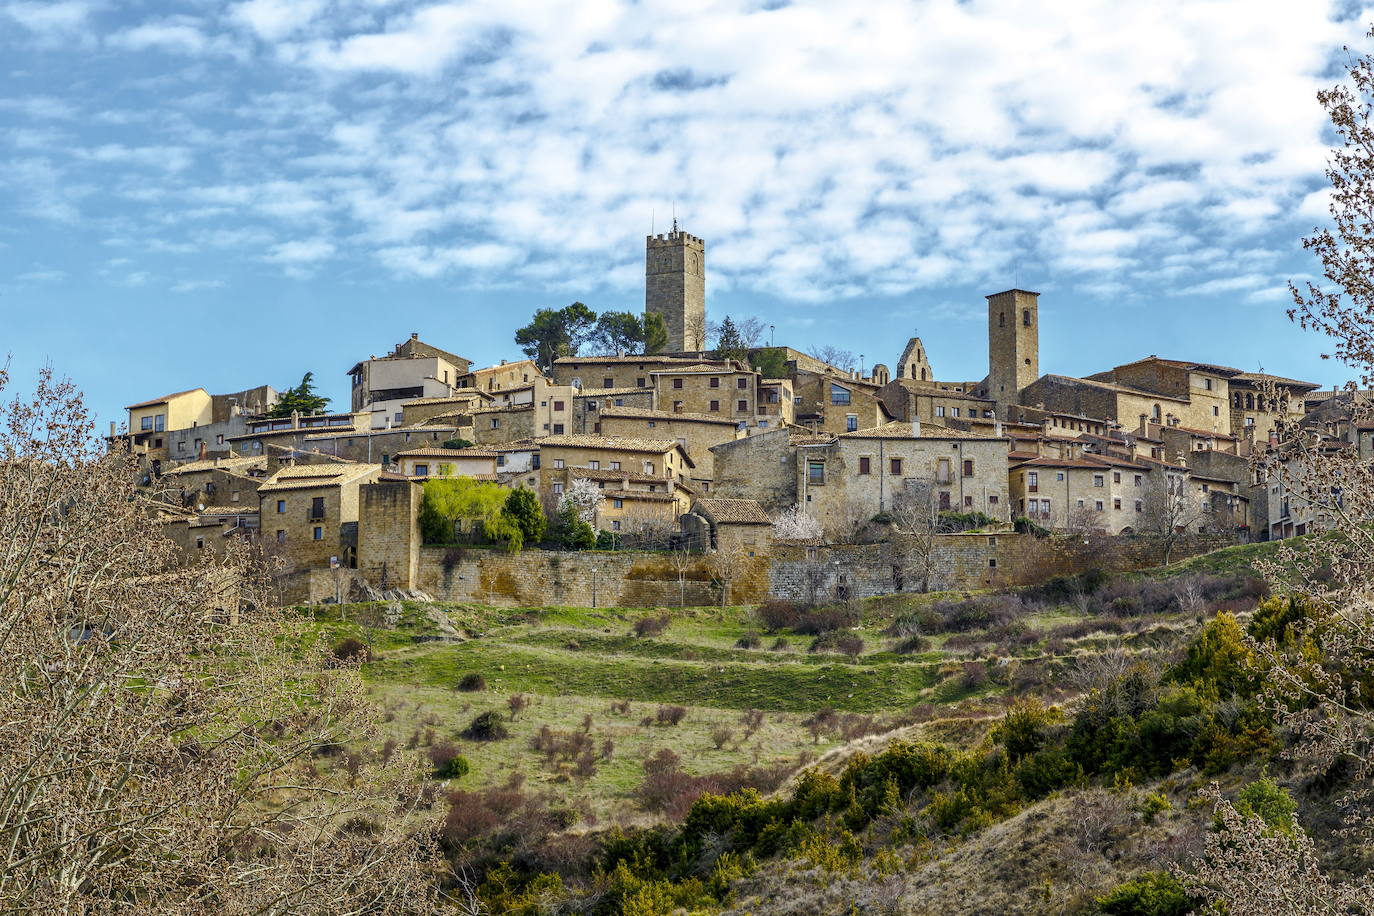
[0,0,1374,423]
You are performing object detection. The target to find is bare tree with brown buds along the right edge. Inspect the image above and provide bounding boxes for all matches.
[1186,33,1374,916]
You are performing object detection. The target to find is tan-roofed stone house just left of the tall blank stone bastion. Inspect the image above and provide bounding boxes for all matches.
[258,463,382,570]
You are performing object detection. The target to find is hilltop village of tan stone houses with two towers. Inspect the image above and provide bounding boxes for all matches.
[110,225,1357,604]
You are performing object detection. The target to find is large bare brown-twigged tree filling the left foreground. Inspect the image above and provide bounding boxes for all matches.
[0,371,438,915]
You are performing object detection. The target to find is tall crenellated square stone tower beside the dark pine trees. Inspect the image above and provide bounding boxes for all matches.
[644,220,706,353]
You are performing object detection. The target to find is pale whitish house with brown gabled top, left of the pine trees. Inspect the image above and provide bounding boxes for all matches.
[348,334,471,430]
